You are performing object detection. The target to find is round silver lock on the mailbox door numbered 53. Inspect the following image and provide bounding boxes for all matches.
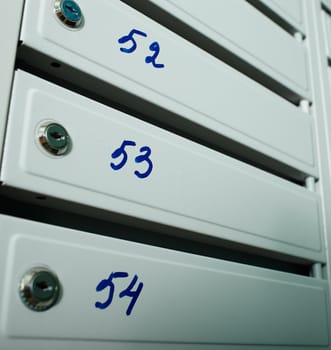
[37,122,71,156]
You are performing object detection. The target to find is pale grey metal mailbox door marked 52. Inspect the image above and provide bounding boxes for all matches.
[22,0,317,175]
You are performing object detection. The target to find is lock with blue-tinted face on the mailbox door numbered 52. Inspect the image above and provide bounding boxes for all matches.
[54,0,83,28]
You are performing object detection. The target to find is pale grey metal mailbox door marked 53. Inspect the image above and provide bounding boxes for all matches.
[1,71,324,261]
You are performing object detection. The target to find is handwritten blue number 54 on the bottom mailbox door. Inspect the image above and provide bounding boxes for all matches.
[95,272,144,316]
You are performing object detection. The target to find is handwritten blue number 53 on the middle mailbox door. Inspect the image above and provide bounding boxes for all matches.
[110,140,153,179]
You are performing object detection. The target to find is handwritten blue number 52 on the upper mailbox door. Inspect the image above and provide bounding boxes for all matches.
[117,29,164,68]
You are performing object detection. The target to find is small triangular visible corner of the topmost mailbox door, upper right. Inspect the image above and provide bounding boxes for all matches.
[259,0,310,33]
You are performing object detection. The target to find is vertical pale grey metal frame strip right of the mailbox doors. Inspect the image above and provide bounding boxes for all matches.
[298,1,331,304]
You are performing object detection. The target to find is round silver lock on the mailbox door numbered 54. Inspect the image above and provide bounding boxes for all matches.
[19,267,60,311]
